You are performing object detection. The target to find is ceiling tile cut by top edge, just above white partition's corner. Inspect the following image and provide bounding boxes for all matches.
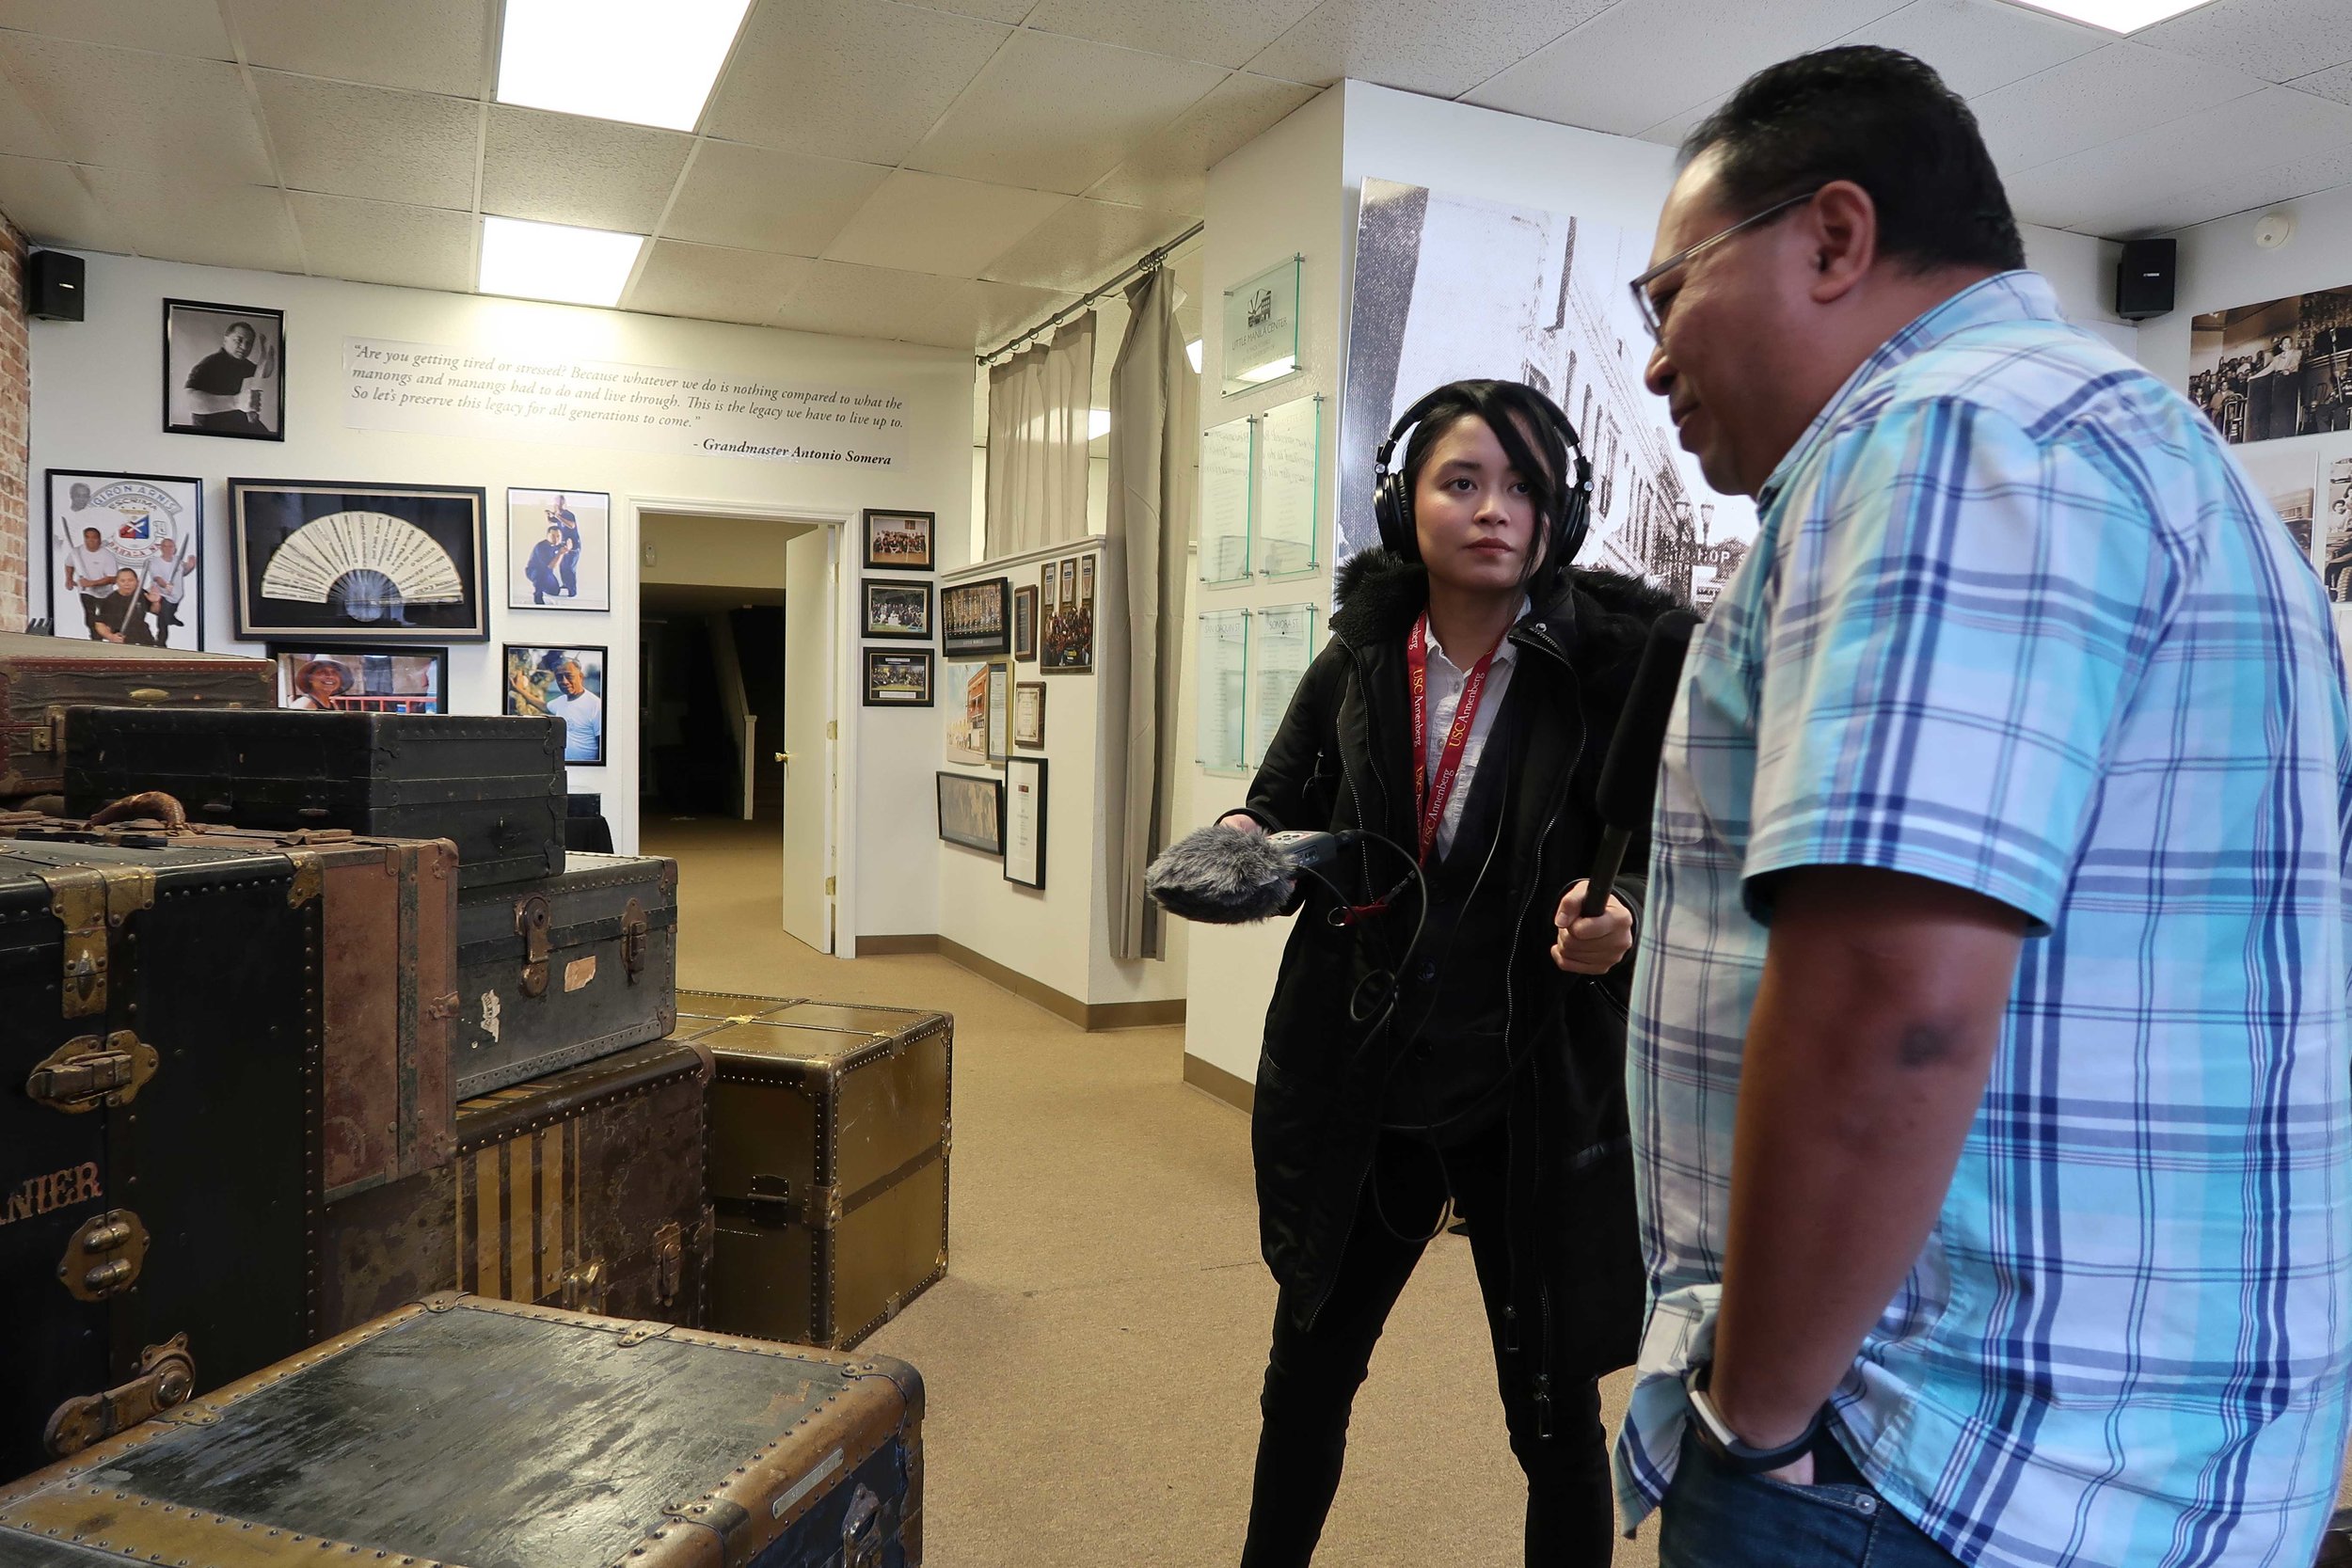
[1247,0,1618,99]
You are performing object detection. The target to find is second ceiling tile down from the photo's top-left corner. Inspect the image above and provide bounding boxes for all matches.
[0,33,276,183]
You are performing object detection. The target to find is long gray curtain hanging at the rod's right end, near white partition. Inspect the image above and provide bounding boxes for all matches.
[1104,268,1200,959]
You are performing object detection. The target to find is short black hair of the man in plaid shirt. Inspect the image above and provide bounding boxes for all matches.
[1682,44,2026,273]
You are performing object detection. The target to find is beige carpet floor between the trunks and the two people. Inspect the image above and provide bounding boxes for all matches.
[644,818,1656,1568]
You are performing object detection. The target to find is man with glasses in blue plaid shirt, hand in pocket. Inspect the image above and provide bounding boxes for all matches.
[1618,47,2352,1568]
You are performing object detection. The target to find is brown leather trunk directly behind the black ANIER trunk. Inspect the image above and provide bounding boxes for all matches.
[0,795,456,1201]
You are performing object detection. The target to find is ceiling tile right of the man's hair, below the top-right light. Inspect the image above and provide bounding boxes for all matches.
[1969,42,2263,174]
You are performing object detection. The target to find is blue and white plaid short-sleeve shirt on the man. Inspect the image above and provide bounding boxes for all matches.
[1618,273,2352,1568]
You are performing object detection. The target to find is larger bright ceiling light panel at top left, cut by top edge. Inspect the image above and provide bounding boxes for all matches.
[499,0,751,132]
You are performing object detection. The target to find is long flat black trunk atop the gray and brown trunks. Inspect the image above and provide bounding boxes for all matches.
[66,707,567,889]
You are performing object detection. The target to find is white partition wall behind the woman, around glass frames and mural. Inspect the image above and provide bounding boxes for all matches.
[1179,82,2131,1079]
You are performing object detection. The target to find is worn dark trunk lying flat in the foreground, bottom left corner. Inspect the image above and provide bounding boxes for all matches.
[0,1295,922,1568]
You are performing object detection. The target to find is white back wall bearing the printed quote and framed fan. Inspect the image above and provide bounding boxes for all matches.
[26,245,972,933]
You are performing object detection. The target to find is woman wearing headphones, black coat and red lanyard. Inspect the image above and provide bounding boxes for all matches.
[1221,381,1670,1568]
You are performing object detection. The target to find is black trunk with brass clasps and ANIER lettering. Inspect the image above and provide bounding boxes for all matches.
[0,842,323,1485]
